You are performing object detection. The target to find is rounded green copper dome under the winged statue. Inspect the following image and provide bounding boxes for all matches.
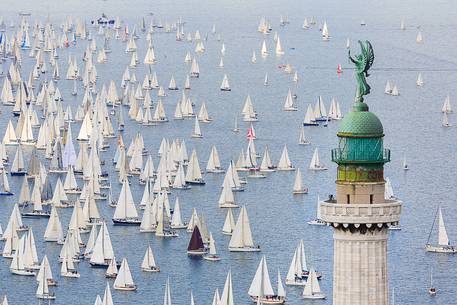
[338,102,384,137]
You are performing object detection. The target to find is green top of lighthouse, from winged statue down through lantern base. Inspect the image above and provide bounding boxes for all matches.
[332,41,390,182]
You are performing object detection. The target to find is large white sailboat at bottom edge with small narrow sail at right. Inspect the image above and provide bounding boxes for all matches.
[248,255,286,304]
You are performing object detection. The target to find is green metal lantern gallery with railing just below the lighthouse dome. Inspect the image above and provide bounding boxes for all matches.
[332,148,390,164]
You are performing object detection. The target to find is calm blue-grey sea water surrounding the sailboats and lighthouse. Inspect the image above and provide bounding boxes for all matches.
[0,0,457,305]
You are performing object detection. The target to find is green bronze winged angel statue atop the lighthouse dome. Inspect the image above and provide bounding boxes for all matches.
[348,40,374,102]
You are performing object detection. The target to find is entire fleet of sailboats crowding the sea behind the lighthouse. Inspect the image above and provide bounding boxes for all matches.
[0,8,444,305]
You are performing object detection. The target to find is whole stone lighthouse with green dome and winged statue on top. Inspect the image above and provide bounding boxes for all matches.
[320,42,402,305]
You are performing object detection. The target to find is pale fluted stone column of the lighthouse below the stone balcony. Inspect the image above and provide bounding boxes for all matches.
[333,224,388,305]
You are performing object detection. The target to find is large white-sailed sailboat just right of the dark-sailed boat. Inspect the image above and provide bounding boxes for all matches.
[229,206,260,252]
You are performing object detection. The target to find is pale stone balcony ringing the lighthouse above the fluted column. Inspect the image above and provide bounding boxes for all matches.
[319,199,402,227]
